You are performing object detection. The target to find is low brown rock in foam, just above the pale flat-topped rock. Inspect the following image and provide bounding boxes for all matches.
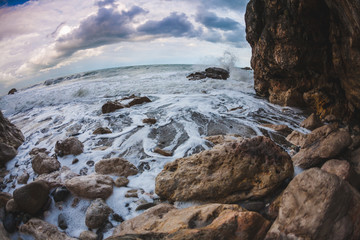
[95,158,138,177]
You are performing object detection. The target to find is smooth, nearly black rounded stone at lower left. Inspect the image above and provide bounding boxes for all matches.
[13,181,50,215]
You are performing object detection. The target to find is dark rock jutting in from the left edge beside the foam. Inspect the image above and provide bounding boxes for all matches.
[0,111,25,166]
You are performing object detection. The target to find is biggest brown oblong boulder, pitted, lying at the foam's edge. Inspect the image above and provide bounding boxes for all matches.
[155,136,293,203]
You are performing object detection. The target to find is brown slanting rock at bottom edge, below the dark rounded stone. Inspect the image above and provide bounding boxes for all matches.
[20,218,76,240]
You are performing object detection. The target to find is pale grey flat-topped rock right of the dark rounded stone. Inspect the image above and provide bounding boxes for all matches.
[65,174,113,199]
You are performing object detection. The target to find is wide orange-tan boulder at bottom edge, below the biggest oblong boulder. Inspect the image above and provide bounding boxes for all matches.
[108,204,270,240]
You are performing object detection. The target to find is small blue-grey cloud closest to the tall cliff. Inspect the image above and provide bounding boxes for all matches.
[195,11,240,31]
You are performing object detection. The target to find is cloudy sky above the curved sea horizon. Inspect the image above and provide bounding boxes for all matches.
[0,0,250,92]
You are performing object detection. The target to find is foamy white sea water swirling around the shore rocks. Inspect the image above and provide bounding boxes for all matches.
[0,65,306,239]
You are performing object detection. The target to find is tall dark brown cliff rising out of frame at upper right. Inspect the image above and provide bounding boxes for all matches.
[245,0,360,120]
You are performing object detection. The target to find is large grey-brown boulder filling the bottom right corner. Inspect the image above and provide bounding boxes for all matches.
[266,168,360,240]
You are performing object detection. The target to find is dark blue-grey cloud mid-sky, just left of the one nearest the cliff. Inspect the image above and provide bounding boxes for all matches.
[137,12,196,37]
